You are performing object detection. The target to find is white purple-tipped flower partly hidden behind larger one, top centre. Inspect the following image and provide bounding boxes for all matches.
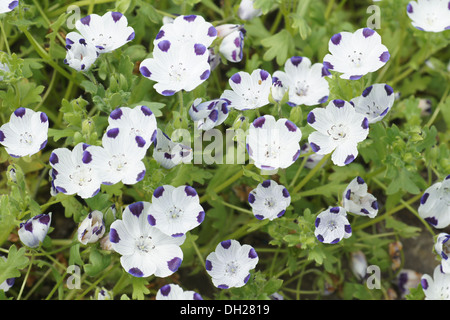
[153,15,217,48]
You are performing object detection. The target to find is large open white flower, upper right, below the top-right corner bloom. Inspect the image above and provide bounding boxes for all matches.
[323,28,390,80]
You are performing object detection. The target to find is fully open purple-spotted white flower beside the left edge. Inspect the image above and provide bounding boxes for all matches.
[0,107,48,158]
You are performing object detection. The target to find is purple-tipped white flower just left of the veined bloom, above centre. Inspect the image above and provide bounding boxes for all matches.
[220,69,272,110]
